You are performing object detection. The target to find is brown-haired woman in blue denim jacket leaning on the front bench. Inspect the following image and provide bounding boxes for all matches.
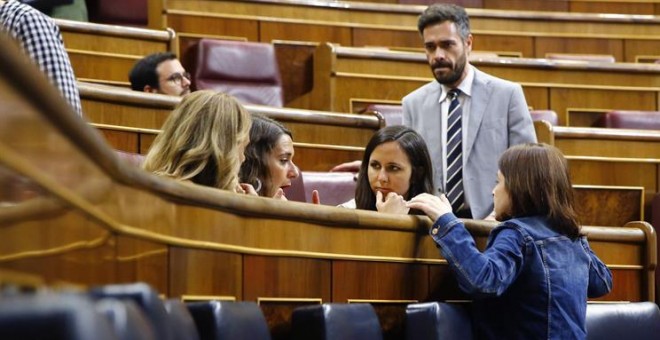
[408,144,612,339]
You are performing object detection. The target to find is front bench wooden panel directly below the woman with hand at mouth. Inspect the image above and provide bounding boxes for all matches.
[332,261,429,303]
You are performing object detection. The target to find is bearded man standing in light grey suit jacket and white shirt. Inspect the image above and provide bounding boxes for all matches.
[403,4,536,219]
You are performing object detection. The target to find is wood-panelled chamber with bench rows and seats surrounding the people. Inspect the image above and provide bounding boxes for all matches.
[0,0,660,340]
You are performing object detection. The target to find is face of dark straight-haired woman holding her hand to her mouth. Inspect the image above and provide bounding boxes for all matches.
[367,142,412,197]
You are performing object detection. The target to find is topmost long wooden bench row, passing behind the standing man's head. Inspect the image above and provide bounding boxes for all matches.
[157,0,660,62]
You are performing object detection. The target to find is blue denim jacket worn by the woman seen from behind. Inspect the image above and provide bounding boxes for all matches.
[431,213,612,339]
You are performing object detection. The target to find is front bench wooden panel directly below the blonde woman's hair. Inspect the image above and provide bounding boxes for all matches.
[168,247,243,300]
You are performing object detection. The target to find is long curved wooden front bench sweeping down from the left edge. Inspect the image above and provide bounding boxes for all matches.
[0,31,657,337]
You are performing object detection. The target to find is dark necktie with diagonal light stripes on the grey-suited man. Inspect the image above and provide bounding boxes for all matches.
[445,89,465,212]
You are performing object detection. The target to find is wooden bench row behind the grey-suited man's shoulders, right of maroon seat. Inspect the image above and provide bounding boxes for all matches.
[301,44,660,119]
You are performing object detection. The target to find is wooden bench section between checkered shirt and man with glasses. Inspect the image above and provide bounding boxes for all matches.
[55,19,179,86]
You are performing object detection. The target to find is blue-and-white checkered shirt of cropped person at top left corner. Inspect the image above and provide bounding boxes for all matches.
[0,0,82,115]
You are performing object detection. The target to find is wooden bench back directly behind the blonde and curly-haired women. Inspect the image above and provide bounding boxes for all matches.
[79,83,376,171]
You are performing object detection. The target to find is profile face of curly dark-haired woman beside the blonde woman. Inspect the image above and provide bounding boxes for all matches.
[264,134,299,197]
